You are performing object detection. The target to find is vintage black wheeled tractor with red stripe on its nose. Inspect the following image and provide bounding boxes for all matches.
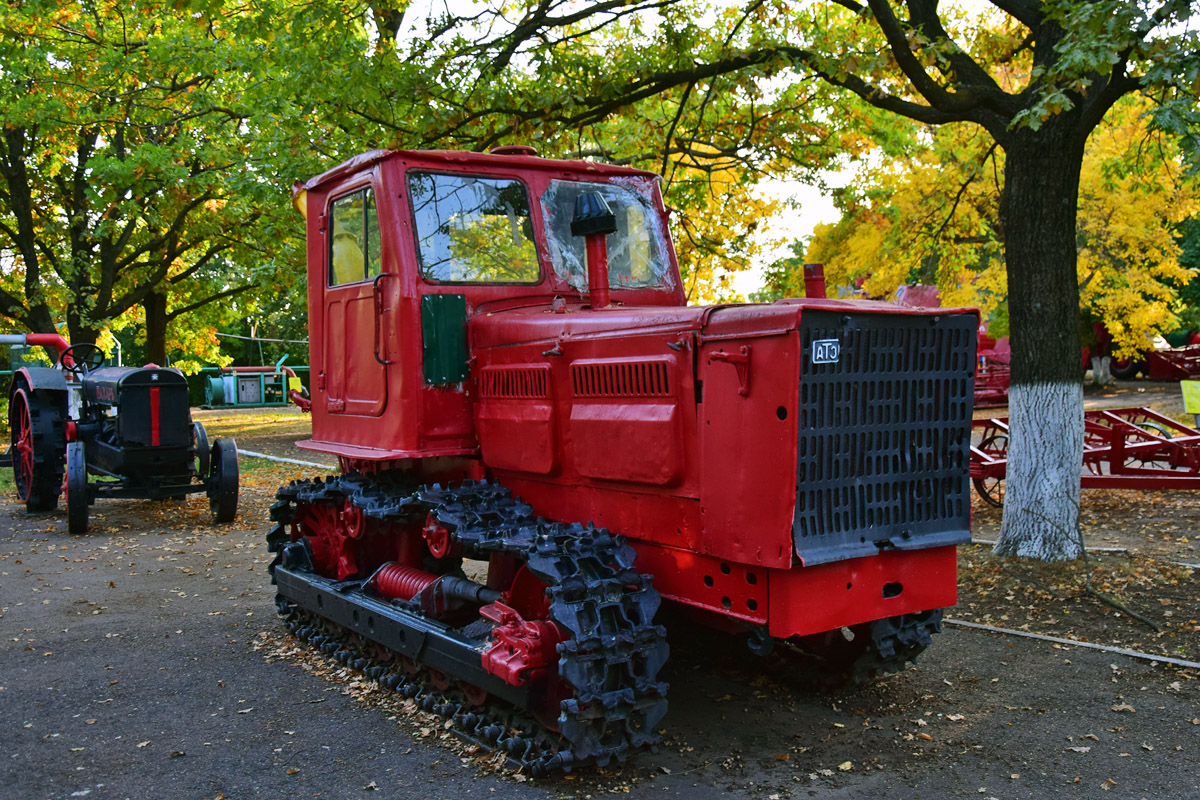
[0,335,238,534]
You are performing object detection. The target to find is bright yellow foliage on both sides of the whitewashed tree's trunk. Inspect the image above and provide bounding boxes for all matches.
[804,98,1200,347]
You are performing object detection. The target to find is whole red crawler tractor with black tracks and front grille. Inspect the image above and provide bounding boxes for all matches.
[269,148,979,772]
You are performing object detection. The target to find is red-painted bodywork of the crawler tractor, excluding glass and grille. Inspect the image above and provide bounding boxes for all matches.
[300,145,973,642]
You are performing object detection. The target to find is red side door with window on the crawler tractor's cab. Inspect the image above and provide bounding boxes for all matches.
[323,185,388,416]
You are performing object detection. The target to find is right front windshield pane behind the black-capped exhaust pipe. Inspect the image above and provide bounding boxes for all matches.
[541,179,667,294]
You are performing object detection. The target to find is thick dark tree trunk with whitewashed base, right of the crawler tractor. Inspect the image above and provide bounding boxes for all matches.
[996,128,1084,560]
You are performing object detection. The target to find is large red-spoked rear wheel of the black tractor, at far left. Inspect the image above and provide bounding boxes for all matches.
[8,384,62,511]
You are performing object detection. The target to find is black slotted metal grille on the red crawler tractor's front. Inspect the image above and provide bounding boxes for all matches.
[793,311,978,564]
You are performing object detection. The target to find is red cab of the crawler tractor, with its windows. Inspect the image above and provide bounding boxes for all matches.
[295,148,684,462]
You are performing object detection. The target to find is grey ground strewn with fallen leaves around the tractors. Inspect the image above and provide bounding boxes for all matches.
[0,407,1200,800]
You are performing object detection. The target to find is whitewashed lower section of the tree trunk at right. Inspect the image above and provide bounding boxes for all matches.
[995,383,1084,561]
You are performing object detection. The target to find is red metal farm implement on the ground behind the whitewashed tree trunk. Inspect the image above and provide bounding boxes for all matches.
[971,408,1200,506]
